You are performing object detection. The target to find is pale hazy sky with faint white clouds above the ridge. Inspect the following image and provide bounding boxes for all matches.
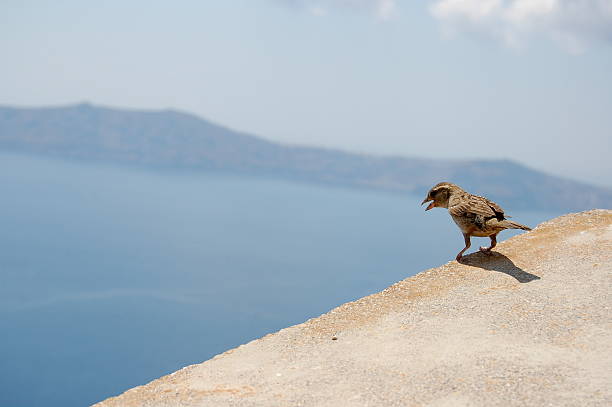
[0,0,612,186]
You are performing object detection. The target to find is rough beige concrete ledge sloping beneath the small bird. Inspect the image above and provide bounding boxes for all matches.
[96,210,612,407]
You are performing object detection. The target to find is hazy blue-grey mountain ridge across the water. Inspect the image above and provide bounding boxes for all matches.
[0,104,612,211]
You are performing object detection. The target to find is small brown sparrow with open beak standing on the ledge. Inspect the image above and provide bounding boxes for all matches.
[421,182,531,262]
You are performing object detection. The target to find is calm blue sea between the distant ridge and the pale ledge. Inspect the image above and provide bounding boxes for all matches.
[0,154,557,407]
